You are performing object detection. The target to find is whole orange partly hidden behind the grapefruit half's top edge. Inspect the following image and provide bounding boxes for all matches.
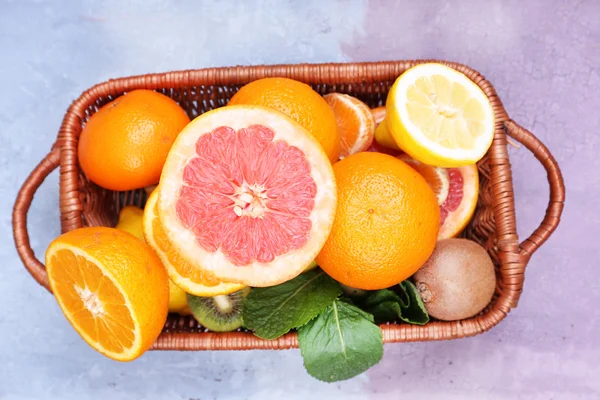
[229,78,340,163]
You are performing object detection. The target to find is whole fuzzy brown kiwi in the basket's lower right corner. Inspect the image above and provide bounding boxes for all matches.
[412,239,496,321]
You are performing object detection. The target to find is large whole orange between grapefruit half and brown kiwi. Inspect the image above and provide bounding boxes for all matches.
[316,152,440,290]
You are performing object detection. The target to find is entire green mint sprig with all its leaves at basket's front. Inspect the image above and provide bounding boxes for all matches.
[243,269,429,382]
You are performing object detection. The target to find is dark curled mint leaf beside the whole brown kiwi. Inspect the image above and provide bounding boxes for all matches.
[363,281,429,325]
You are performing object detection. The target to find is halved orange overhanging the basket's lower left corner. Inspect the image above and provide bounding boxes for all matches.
[46,227,169,361]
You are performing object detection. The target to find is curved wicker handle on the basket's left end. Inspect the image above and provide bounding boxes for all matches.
[13,146,60,291]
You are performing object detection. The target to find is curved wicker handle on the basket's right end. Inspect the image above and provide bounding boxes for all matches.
[504,120,565,257]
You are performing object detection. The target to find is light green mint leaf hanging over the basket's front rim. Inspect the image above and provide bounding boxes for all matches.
[298,300,383,382]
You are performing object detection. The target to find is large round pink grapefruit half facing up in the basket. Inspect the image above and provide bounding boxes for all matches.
[158,105,337,287]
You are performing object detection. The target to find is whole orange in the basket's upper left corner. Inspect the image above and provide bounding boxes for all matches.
[78,90,190,191]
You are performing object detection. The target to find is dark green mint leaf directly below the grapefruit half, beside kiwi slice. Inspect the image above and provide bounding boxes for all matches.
[243,269,342,339]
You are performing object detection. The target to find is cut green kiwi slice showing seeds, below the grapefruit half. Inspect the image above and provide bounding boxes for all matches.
[187,287,250,332]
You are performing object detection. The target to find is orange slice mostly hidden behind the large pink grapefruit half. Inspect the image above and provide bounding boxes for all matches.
[143,190,244,297]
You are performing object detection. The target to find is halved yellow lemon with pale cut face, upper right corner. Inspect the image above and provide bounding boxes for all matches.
[386,63,494,167]
